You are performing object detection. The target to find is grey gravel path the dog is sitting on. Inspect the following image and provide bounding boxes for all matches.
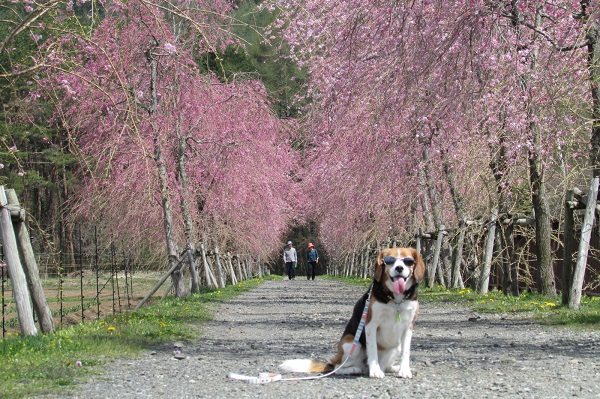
[58,277,600,399]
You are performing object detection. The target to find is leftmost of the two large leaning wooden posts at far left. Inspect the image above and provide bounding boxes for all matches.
[0,186,37,335]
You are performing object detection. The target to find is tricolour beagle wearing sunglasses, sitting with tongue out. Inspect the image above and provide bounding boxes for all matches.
[279,248,425,378]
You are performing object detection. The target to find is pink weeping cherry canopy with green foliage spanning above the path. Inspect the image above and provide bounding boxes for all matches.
[0,0,600,290]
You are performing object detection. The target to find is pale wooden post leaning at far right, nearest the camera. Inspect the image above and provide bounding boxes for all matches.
[569,177,598,309]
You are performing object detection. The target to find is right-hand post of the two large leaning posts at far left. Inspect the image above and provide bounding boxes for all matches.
[6,189,54,333]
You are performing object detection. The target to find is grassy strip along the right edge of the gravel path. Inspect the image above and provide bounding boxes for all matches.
[329,277,600,330]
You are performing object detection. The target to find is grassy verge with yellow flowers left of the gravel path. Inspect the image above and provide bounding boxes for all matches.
[0,279,264,399]
